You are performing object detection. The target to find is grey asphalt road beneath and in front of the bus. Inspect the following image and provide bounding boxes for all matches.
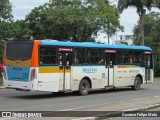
[0,80,160,111]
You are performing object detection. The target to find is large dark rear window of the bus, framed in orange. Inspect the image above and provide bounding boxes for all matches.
[6,41,33,60]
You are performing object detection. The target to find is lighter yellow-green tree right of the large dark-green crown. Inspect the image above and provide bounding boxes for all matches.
[85,0,123,44]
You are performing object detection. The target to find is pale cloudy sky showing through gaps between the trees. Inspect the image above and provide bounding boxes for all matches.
[10,0,160,41]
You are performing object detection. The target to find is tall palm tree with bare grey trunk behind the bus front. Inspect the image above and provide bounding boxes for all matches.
[118,0,159,45]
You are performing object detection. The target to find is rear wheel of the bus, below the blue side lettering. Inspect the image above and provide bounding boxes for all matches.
[79,79,90,95]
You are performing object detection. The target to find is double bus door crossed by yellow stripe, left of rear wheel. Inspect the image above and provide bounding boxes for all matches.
[59,48,73,90]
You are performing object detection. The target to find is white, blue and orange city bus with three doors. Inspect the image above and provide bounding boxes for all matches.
[2,40,154,95]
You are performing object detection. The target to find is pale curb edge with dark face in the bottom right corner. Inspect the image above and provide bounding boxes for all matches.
[72,103,160,120]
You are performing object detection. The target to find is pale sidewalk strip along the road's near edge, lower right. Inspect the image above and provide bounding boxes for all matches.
[31,96,160,120]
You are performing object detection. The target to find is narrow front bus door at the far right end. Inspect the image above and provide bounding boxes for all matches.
[144,51,152,83]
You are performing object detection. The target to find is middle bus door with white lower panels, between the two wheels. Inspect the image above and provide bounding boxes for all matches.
[105,50,115,86]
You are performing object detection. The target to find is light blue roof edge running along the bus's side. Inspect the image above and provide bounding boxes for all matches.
[41,40,152,51]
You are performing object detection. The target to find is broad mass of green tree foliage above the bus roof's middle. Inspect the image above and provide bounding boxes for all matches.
[26,0,121,42]
